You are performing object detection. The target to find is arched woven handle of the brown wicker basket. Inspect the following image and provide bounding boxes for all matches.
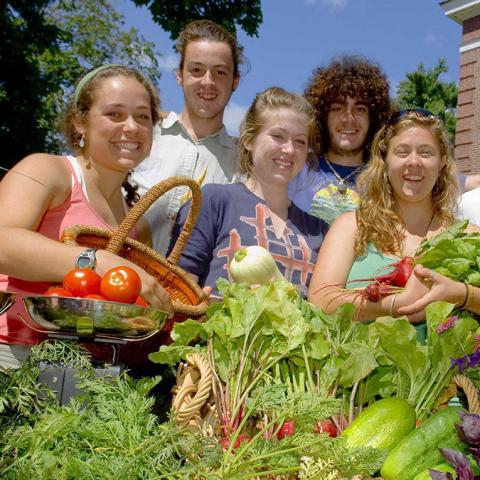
[105,177,202,265]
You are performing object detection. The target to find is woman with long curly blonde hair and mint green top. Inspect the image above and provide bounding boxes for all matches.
[309,109,475,336]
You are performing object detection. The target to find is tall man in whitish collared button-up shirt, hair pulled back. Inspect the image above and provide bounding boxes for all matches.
[132,20,243,255]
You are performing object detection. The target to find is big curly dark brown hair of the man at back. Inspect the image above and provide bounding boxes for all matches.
[304,55,392,159]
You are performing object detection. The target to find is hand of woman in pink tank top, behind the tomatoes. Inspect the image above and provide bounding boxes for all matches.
[96,250,174,317]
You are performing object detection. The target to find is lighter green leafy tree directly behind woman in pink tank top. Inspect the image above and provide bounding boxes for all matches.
[39,0,160,151]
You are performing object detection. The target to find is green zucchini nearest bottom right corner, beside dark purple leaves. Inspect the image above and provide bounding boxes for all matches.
[380,407,465,480]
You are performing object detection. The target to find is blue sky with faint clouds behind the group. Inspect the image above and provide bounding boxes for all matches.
[116,0,462,134]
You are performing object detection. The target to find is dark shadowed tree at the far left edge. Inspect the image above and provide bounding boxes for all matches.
[0,0,60,172]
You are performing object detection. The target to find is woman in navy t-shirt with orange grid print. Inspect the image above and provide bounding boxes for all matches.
[172,87,328,295]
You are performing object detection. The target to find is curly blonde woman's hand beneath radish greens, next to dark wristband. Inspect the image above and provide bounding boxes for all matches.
[397,265,466,321]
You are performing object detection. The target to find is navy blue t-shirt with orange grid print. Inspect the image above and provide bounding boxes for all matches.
[170,183,328,296]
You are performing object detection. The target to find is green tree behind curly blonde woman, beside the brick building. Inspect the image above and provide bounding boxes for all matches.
[396,58,458,141]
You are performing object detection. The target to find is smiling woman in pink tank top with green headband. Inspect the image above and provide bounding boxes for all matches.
[0,65,172,364]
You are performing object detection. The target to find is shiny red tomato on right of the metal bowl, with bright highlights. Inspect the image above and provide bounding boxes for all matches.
[100,266,142,303]
